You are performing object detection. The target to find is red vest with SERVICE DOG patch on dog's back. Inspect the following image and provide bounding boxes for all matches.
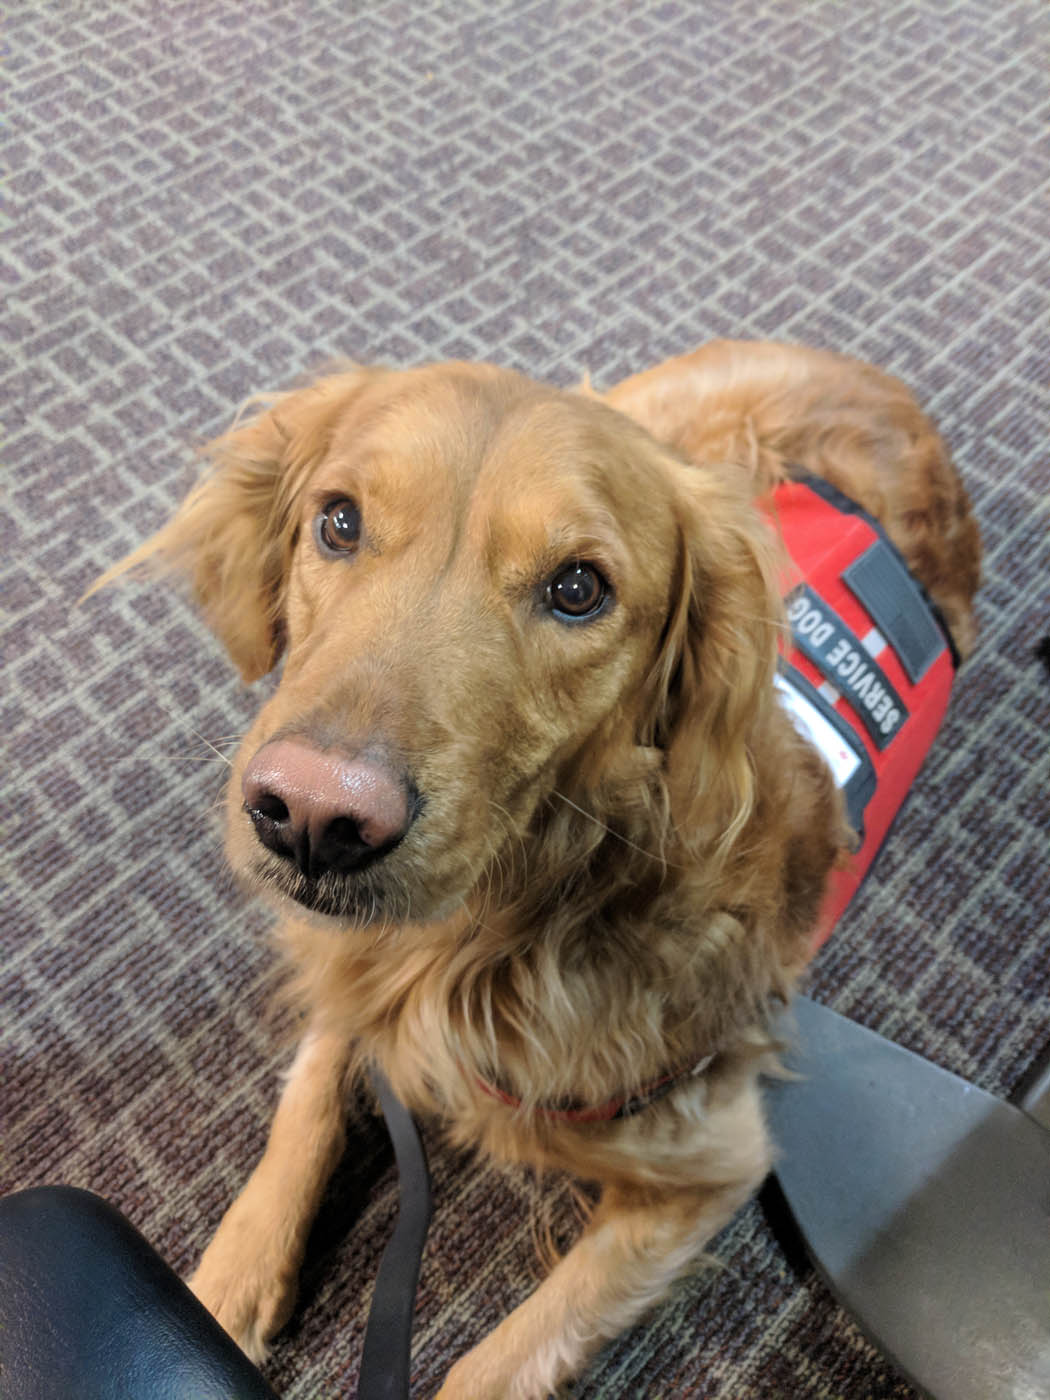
[770,476,958,952]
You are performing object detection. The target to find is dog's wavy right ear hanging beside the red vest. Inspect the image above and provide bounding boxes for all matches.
[650,462,784,854]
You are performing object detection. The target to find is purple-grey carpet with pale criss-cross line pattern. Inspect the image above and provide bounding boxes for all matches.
[0,0,1050,1400]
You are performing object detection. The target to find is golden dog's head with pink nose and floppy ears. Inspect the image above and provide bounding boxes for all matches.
[113,364,780,923]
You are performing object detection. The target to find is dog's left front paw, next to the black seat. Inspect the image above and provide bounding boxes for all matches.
[189,1211,298,1365]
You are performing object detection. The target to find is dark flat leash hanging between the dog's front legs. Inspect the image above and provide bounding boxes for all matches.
[357,1067,431,1400]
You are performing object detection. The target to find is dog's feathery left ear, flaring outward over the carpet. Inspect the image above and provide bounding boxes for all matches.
[88,370,382,682]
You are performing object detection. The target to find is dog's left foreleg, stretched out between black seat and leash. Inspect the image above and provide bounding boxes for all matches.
[190,1029,351,1361]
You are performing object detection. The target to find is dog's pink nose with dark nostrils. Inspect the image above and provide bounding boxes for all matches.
[241,739,414,879]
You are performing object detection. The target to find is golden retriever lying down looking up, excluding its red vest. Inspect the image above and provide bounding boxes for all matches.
[102,343,980,1400]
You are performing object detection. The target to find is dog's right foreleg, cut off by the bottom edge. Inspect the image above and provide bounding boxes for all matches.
[438,1177,760,1400]
